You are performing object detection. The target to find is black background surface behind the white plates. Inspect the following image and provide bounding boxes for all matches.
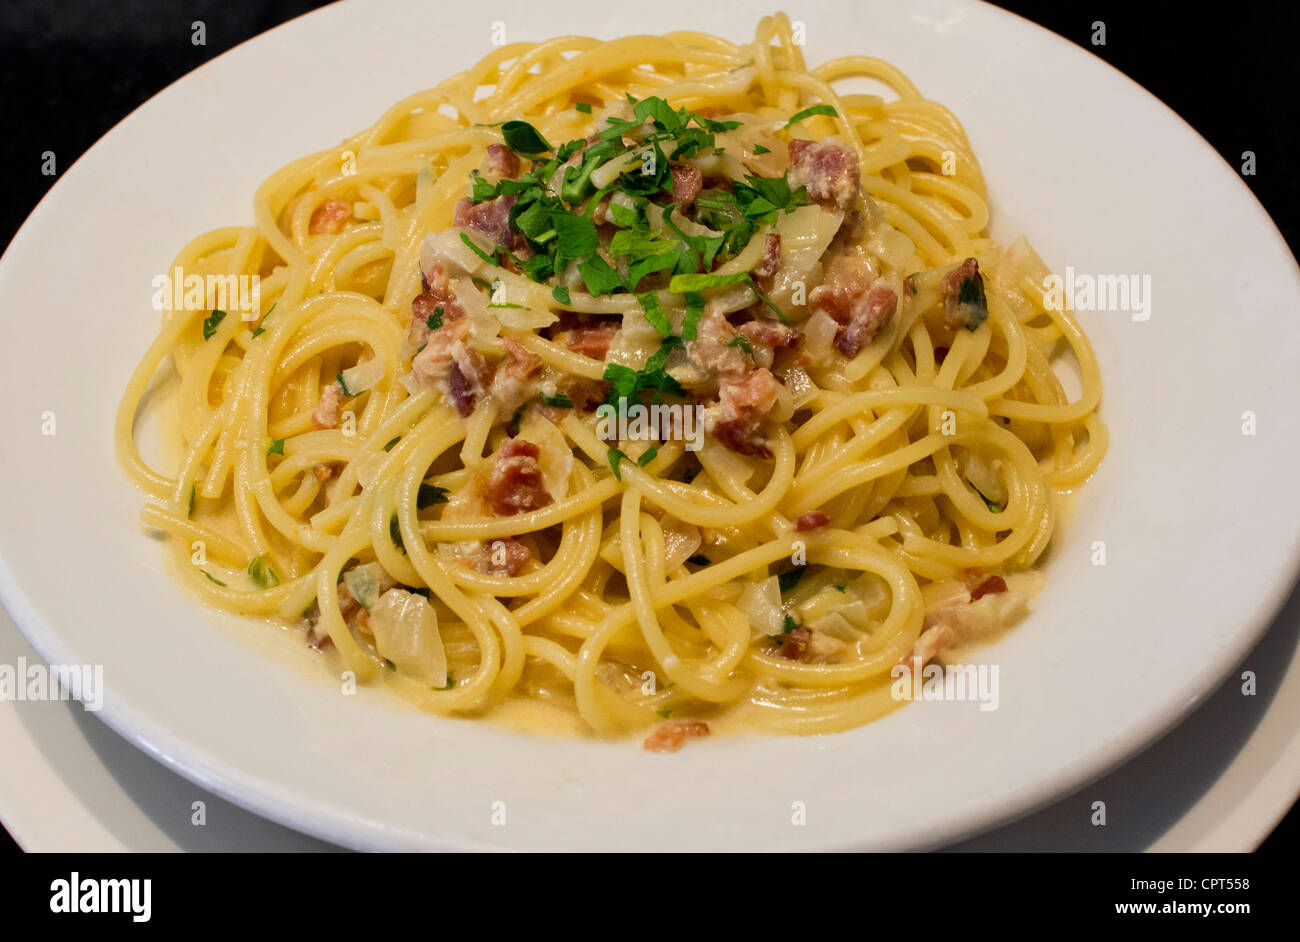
[0,0,1300,851]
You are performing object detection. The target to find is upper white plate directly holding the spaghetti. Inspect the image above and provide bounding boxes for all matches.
[0,0,1300,850]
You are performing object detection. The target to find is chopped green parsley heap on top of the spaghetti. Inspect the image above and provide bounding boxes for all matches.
[454,95,811,327]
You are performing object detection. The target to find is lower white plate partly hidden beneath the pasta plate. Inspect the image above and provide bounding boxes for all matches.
[0,579,1300,854]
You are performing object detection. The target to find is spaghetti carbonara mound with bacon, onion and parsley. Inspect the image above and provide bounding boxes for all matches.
[117,14,1106,750]
